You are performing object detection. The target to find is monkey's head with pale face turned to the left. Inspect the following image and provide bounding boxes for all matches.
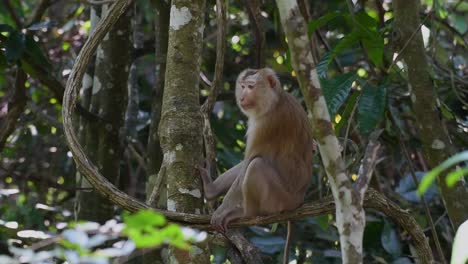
[236,68,282,118]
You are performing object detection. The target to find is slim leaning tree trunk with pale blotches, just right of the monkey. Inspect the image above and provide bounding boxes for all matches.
[276,0,367,264]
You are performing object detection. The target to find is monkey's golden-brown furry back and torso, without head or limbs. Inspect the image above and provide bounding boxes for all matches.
[245,92,314,200]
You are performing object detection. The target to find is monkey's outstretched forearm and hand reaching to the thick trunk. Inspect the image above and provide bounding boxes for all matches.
[201,162,244,200]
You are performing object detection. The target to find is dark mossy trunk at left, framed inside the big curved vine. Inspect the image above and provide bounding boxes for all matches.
[80,5,132,222]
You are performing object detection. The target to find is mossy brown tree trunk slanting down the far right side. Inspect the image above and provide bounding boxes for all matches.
[393,0,468,229]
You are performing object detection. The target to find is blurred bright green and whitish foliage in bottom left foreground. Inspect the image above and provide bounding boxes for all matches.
[0,210,202,264]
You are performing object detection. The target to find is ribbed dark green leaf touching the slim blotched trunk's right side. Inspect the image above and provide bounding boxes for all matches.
[320,73,357,117]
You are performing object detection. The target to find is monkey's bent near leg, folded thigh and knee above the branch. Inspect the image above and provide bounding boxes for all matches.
[242,157,297,216]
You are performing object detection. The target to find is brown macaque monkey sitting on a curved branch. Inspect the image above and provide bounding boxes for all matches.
[201,68,314,262]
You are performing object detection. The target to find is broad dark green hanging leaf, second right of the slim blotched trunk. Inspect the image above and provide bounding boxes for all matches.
[357,84,387,135]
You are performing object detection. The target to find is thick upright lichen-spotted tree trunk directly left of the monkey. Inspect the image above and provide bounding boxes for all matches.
[159,0,210,263]
